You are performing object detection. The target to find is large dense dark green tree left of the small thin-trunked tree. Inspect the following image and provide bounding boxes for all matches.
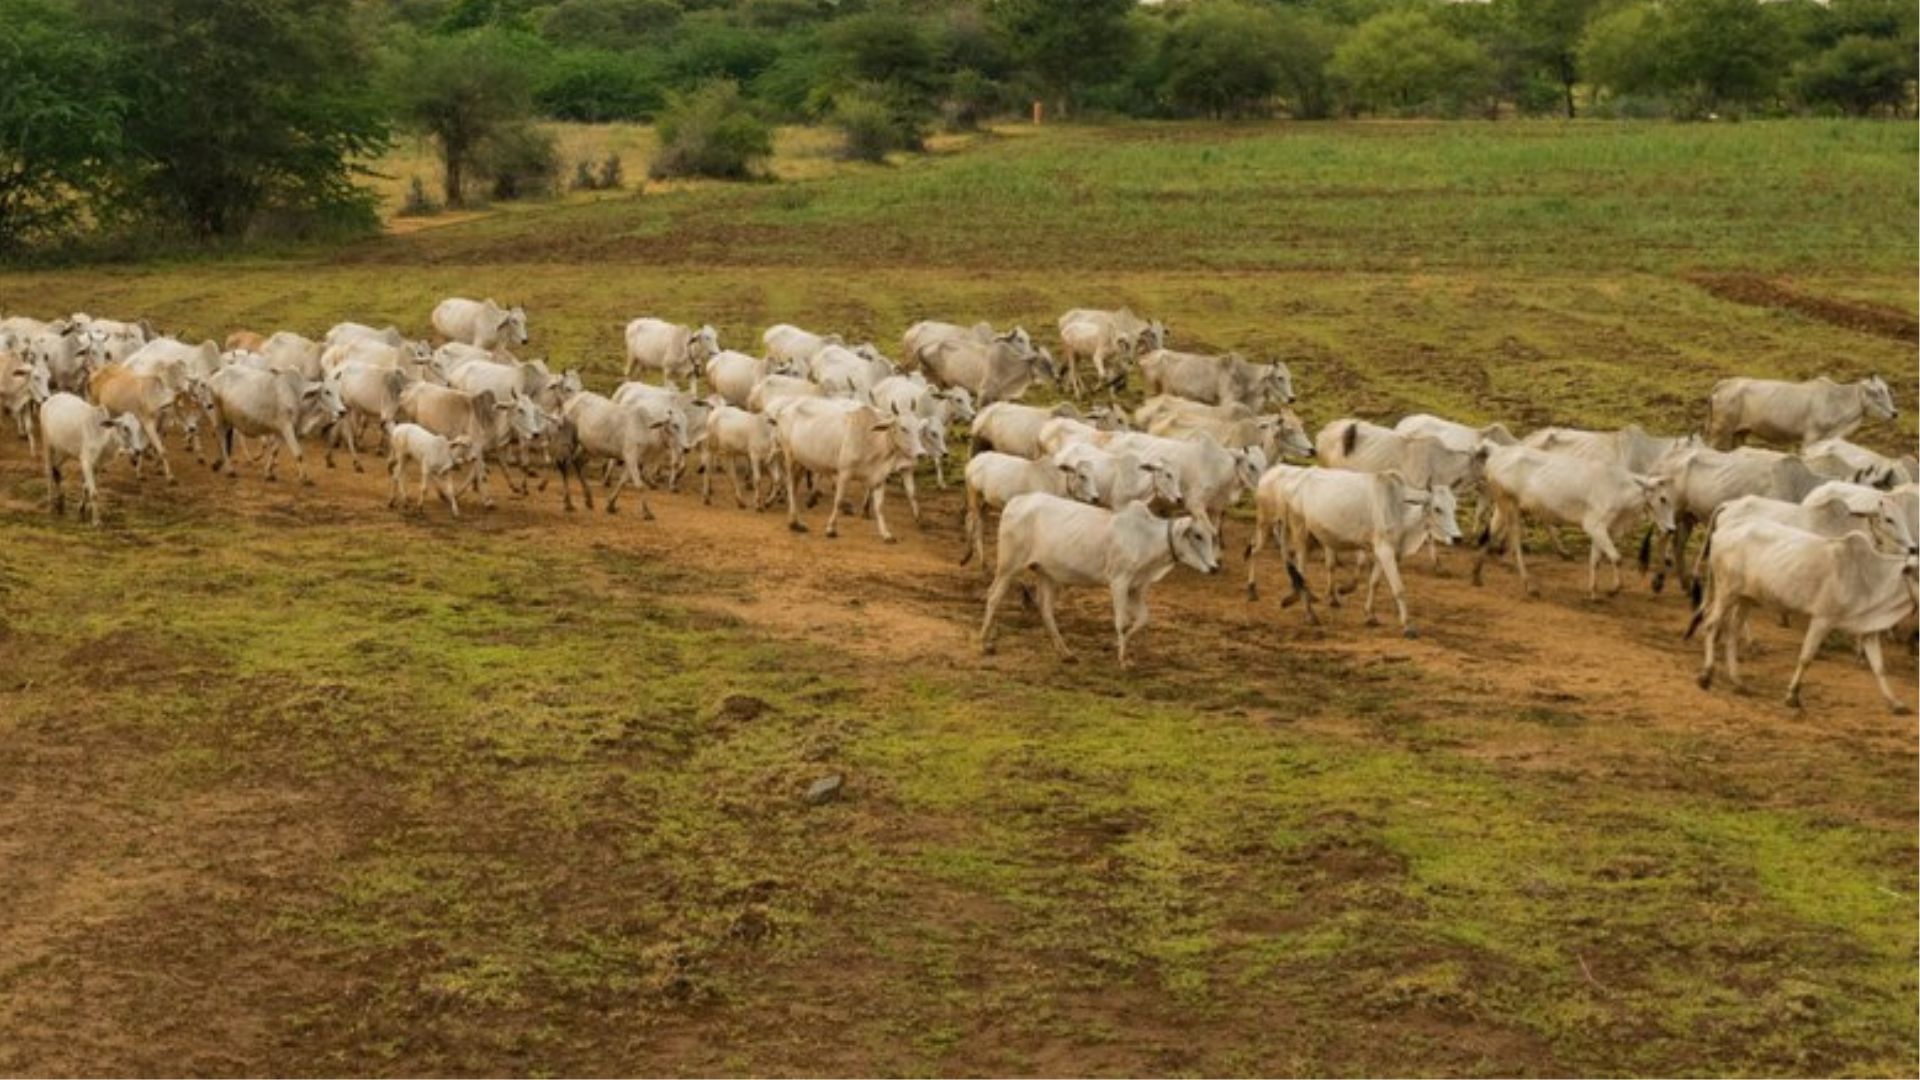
[83,0,388,236]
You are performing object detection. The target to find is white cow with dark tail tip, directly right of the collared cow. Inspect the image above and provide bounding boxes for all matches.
[1246,465,1459,638]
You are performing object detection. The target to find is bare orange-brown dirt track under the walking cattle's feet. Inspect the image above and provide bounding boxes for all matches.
[11,428,1914,751]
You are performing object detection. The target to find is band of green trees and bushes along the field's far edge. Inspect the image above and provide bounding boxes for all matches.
[0,0,1916,252]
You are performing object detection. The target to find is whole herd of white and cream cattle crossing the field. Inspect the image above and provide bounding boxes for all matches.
[0,298,1920,711]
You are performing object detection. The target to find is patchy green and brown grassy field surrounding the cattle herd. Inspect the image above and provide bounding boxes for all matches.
[0,121,1920,1076]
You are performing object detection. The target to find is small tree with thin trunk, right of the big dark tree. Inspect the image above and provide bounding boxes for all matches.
[388,29,534,206]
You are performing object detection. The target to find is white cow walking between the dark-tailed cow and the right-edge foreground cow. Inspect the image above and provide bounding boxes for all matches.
[1473,446,1674,600]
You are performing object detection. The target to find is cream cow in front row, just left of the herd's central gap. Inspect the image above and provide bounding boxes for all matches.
[774,398,925,544]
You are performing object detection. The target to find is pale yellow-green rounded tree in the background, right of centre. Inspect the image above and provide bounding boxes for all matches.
[1331,10,1488,111]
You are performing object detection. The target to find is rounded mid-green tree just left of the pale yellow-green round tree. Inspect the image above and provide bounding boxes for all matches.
[1162,0,1281,117]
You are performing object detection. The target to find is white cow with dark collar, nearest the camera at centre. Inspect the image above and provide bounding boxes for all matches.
[979,492,1219,669]
